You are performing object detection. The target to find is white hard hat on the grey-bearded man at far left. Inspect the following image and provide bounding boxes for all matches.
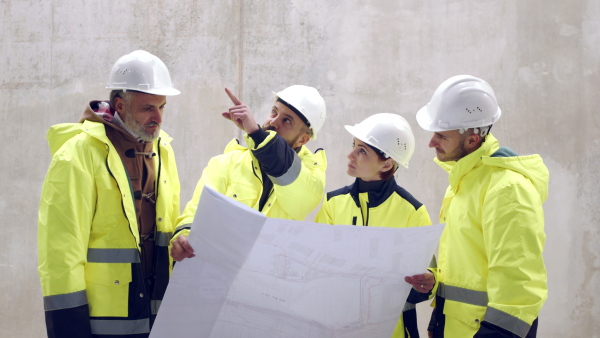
[106,50,181,95]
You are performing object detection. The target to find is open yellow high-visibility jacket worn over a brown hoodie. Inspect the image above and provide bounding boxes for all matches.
[38,120,180,337]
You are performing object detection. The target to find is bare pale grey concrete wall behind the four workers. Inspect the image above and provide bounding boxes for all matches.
[0,0,600,337]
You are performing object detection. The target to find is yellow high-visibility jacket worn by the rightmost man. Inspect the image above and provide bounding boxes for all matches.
[436,134,549,337]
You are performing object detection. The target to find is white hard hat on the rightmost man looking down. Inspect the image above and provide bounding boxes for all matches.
[417,75,502,131]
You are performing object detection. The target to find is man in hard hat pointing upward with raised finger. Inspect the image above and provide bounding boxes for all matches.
[171,85,327,261]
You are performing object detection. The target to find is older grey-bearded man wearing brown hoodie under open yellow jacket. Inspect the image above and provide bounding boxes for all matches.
[38,50,179,338]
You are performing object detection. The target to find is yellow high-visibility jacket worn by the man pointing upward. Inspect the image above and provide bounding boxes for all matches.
[174,131,327,239]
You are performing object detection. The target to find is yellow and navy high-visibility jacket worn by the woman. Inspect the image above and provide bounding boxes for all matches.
[315,177,431,338]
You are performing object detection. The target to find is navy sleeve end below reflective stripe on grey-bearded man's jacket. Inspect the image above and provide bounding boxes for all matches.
[46,304,92,338]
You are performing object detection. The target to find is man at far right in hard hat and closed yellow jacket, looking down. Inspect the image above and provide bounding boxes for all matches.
[417,75,549,338]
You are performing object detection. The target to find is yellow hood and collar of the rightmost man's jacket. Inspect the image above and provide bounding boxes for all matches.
[434,133,550,202]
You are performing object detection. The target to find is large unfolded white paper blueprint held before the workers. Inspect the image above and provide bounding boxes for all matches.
[150,188,443,338]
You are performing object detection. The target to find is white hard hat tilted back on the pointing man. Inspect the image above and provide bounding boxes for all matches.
[273,85,326,140]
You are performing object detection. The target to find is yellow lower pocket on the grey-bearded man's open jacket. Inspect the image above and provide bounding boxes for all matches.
[85,263,131,317]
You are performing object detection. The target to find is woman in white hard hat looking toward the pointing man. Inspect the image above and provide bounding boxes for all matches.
[316,113,433,337]
